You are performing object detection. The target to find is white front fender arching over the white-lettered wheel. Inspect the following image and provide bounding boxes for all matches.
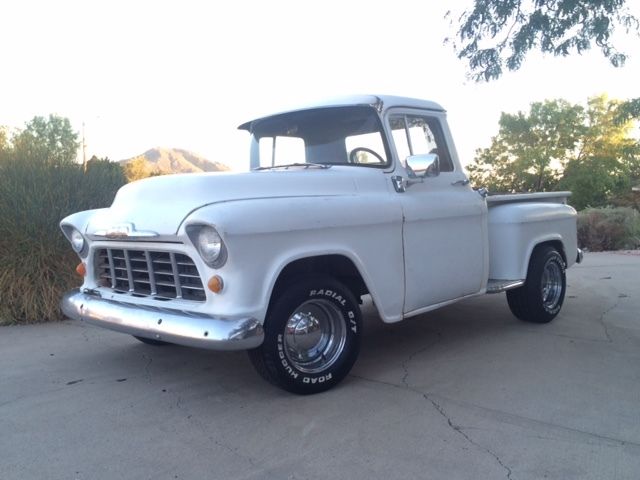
[181,194,404,322]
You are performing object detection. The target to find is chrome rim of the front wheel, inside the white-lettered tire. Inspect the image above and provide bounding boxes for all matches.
[284,299,347,373]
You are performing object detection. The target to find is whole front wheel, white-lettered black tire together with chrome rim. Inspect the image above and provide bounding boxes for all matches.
[249,276,362,394]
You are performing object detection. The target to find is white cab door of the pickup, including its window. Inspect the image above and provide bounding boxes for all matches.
[388,112,488,314]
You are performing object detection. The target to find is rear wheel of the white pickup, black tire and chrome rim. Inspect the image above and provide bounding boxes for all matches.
[507,245,567,323]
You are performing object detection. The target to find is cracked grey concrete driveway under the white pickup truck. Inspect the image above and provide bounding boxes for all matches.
[0,253,640,480]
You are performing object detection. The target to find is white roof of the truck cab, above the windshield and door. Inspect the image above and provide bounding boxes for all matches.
[238,95,445,131]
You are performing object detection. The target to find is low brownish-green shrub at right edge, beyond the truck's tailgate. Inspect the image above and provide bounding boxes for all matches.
[578,207,640,252]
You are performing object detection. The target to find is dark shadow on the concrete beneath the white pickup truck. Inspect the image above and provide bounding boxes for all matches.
[79,295,521,395]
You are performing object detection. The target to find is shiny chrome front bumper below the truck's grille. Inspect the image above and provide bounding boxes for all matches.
[60,289,264,350]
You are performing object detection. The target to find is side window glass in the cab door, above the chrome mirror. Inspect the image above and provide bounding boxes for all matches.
[389,115,453,172]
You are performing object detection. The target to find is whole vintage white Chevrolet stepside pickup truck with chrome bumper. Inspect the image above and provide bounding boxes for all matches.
[61,96,582,394]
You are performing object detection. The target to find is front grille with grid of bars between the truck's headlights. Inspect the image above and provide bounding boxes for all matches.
[95,248,206,302]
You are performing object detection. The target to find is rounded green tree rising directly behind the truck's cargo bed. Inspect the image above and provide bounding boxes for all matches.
[468,100,584,192]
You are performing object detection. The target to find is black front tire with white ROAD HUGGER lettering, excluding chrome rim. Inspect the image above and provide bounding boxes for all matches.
[263,278,362,393]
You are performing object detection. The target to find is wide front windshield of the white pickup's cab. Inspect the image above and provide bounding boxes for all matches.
[251,106,389,168]
